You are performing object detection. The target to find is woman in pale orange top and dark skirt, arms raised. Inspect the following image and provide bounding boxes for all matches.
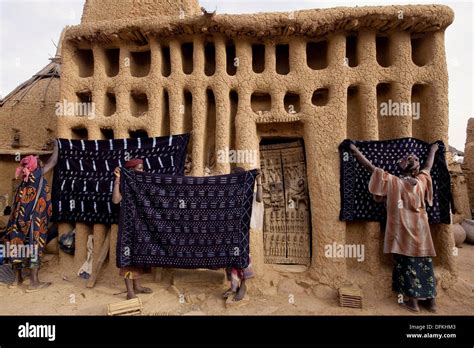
[351,144,438,313]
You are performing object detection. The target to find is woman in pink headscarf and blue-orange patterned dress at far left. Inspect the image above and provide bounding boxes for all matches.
[6,141,58,292]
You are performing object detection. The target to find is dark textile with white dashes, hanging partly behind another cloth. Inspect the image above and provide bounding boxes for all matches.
[52,134,189,223]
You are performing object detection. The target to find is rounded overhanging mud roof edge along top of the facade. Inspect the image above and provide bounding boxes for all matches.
[65,5,454,44]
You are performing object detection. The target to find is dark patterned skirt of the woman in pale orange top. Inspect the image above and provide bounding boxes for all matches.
[392,254,436,299]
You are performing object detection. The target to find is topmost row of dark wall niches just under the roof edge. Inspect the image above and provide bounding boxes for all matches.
[74,33,434,77]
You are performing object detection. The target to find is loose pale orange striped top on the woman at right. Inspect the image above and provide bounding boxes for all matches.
[369,168,436,256]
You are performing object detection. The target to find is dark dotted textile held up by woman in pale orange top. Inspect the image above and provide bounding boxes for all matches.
[339,138,452,224]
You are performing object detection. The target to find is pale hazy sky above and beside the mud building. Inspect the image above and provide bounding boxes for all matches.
[0,0,474,150]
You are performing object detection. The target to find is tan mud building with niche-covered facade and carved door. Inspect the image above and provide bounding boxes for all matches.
[2,0,456,294]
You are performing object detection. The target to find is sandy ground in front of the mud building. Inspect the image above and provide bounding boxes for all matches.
[0,244,474,316]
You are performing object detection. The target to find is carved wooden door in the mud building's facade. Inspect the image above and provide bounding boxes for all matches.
[260,141,311,265]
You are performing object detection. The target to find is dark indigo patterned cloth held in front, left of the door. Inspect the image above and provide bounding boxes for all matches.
[117,169,257,269]
